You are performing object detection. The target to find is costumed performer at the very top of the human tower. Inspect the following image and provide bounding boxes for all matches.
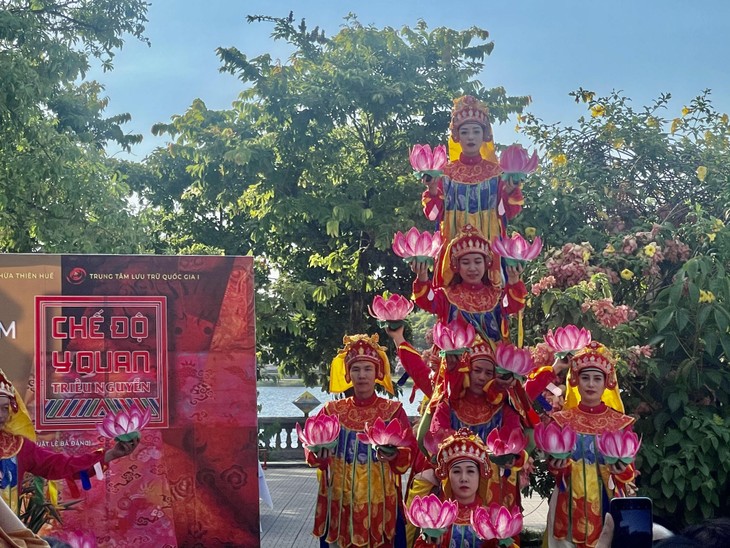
[423,95,523,246]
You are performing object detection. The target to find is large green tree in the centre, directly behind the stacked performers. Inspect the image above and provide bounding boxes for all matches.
[139,15,528,382]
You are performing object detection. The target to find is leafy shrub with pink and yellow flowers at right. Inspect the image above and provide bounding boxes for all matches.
[518,89,730,523]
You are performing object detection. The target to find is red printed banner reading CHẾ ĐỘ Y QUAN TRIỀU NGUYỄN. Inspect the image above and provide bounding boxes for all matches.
[0,255,259,547]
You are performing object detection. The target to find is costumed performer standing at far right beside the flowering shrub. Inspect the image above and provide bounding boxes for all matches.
[546,341,635,548]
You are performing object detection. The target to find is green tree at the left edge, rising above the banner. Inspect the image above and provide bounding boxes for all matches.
[0,0,147,252]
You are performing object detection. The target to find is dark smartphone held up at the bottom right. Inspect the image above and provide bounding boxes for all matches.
[610,497,654,548]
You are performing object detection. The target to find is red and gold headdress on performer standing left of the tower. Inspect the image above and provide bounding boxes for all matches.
[330,333,393,394]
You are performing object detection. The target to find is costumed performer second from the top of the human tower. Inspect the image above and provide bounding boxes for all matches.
[411,225,527,341]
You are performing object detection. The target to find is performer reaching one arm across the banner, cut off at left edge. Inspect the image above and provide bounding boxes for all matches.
[0,370,139,546]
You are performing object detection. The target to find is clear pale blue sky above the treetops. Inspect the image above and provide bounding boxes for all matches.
[88,0,730,160]
